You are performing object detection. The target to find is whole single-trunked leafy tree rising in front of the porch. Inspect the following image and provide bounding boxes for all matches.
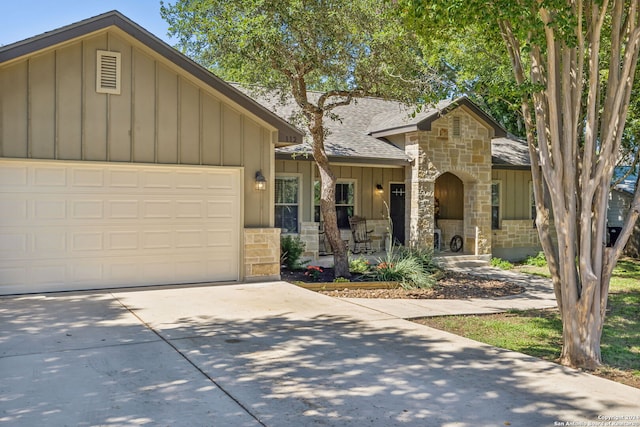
[161,0,437,277]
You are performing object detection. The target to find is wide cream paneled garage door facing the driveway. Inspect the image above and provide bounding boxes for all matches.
[0,159,242,294]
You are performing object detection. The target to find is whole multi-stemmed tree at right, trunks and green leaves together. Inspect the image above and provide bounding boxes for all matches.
[401,0,640,367]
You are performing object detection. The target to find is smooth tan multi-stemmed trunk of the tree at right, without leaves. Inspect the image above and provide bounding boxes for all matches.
[500,0,640,369]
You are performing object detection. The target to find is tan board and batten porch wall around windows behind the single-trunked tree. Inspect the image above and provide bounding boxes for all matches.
[276,160,405,221]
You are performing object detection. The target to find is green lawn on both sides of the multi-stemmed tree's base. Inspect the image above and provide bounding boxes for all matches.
[419,259,640,388]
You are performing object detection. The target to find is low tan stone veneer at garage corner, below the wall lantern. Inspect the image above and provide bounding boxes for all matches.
[244,228,280,282]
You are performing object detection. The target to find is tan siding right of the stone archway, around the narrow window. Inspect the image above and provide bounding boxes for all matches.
[492,169,531,219]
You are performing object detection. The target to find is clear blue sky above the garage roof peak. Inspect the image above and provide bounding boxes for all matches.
[0,0,175,46]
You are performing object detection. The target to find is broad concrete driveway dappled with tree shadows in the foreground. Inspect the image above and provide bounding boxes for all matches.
[0,282,640,427]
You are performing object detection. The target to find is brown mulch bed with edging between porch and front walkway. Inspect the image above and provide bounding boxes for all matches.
[281,268,524,299]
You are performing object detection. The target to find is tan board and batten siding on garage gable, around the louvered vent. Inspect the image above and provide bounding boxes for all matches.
[0,27,277,227]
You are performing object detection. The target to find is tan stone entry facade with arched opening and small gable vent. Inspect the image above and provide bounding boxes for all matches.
[405,108,491,255]
